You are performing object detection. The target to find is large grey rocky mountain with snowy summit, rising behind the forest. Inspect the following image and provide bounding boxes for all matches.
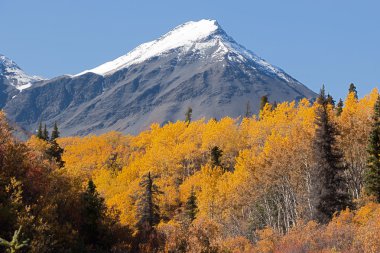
[5,20,315,135]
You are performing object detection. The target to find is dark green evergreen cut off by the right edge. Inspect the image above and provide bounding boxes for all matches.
[364,96,380,202]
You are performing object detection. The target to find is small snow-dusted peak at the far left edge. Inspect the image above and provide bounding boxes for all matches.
[0,54,44,91]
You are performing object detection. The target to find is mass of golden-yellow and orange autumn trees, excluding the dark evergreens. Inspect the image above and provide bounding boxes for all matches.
[16,90,380,252]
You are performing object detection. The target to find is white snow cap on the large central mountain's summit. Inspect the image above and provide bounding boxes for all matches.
[75,19,289,81]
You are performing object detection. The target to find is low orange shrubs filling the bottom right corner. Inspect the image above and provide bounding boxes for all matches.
[268,203,380,253]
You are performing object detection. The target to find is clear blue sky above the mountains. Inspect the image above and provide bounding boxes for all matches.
[0,0,380,99]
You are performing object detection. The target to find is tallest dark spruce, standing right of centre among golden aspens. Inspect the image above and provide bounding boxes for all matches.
[311,87,351,223]
